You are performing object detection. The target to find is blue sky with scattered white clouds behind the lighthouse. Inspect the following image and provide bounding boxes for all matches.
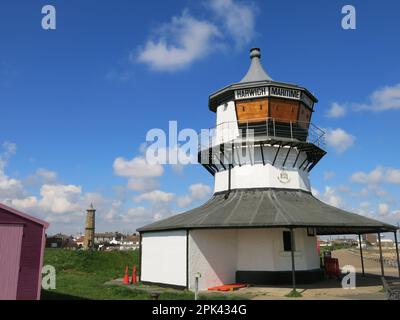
[0,0,400,233]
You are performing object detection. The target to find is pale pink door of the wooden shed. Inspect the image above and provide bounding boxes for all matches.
[0,225,23,300]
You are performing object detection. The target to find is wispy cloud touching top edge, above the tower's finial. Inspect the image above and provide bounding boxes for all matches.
[208,0,256,46]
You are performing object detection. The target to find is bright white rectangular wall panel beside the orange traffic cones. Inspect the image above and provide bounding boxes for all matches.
[141,230,187,286]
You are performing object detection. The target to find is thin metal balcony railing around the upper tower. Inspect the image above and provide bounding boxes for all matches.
[199,118,325,151]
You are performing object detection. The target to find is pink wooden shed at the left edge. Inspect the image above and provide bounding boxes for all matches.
[0,203,49,300]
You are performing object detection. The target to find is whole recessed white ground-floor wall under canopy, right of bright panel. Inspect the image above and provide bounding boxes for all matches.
[189,229,319,290]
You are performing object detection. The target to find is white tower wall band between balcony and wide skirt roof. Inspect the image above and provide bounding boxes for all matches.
[214,147,311,192]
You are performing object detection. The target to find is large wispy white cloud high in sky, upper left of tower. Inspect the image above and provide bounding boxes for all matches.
[136,11,221,71]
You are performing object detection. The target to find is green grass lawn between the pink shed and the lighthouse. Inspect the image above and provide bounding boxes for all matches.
[42,249,244,300]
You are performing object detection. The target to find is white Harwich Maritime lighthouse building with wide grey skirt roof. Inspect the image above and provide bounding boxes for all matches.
[138,48,396,290]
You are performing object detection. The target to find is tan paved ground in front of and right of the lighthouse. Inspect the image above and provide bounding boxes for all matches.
[205,250,398,300]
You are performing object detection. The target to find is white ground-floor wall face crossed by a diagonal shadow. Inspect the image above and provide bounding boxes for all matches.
[189,229,237,290]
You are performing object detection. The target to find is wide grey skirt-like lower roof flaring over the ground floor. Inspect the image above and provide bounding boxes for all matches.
[138,189,397,235]
